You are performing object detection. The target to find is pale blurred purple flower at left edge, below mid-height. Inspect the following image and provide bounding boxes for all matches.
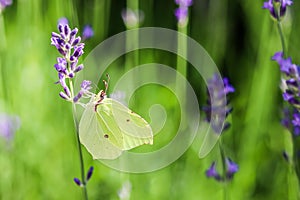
[0,113,21,142]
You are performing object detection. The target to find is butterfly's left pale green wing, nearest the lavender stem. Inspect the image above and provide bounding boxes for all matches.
[79,102,122,159]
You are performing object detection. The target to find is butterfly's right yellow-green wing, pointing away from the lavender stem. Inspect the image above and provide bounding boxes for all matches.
[97,98,153,150]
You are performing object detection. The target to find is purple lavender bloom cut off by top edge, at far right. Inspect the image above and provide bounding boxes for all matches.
[262,0,293,20]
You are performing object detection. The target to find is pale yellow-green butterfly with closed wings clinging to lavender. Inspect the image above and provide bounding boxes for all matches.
[79,75,153,160]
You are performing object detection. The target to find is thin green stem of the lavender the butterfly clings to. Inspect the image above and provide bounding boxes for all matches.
[69,79,88,200]
